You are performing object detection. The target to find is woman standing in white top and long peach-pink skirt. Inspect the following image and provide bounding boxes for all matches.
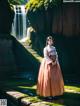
[37,36,64,97]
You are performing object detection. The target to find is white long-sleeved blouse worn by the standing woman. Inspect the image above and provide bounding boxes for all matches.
[43,45,58,63]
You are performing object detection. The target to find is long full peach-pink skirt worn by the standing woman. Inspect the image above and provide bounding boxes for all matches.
[37,59,64,97]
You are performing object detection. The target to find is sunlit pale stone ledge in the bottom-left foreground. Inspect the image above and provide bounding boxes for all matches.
[4,90,49,106]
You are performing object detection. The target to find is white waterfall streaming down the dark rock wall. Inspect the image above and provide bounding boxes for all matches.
[11,5,28,40]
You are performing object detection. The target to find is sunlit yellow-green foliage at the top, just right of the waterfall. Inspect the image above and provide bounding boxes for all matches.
[26,0,61,12]
